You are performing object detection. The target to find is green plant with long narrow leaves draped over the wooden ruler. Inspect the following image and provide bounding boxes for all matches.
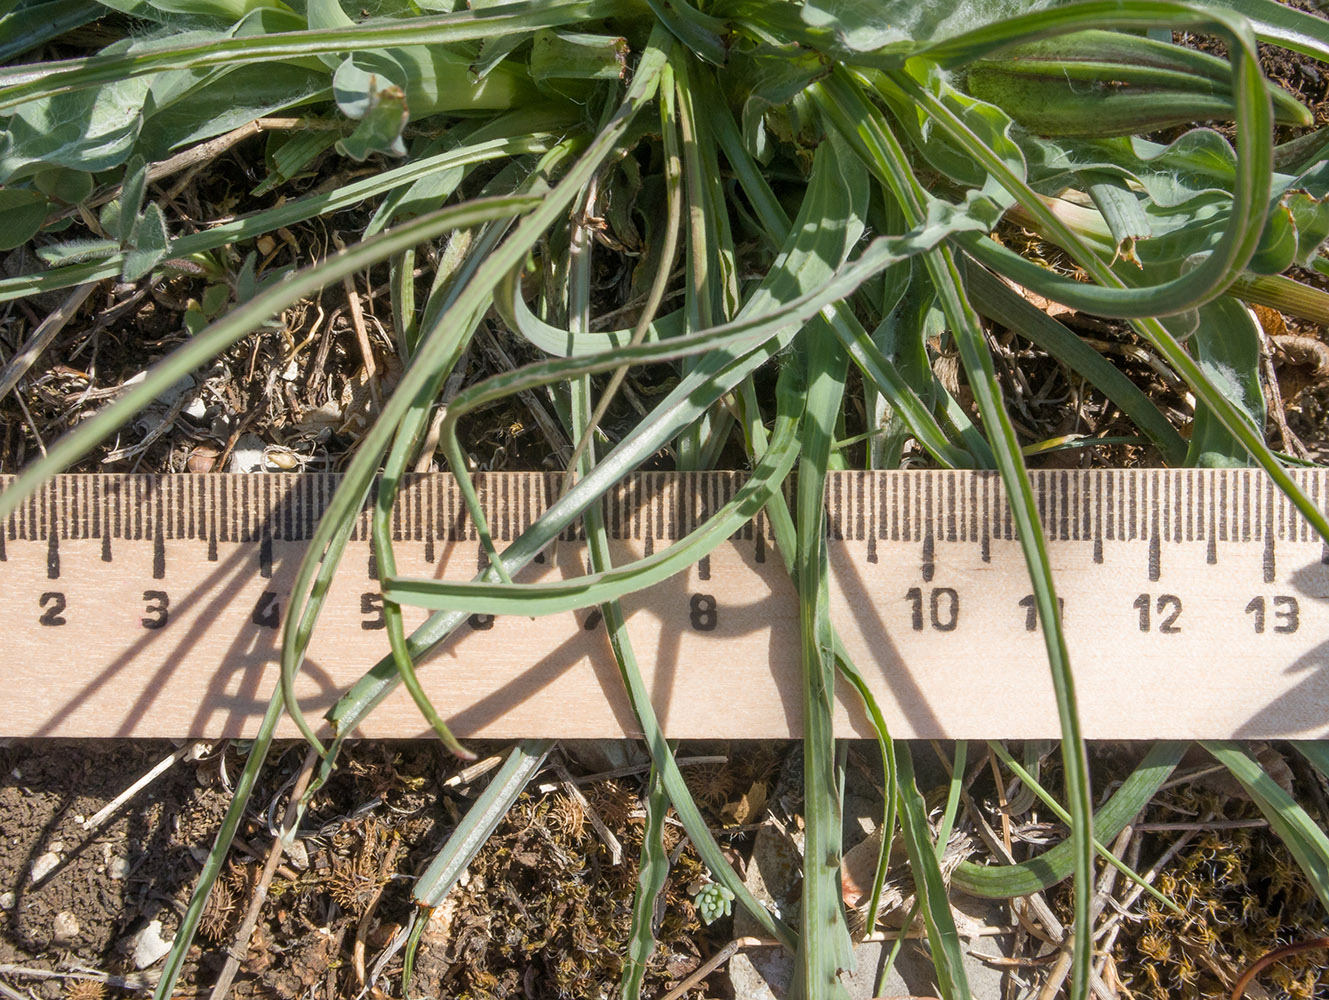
[0,0,1329,997]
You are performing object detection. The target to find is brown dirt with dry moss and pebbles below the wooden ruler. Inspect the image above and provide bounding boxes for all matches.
[0,741,1329,1000]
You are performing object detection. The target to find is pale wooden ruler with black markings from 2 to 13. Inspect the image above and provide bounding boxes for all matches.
[0,469,1329,739]
